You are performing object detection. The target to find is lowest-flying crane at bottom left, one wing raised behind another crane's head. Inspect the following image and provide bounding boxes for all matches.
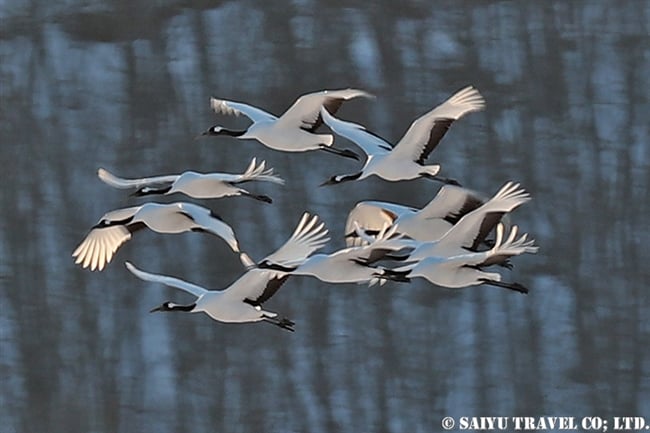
[126,213,328,331]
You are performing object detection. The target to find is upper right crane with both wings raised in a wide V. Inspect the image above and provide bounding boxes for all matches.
[321,86,485,185]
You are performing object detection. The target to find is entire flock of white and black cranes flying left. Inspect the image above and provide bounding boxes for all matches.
[72,86,538,331]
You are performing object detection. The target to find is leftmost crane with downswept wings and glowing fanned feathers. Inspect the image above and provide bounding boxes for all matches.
[72,202,239,271]
